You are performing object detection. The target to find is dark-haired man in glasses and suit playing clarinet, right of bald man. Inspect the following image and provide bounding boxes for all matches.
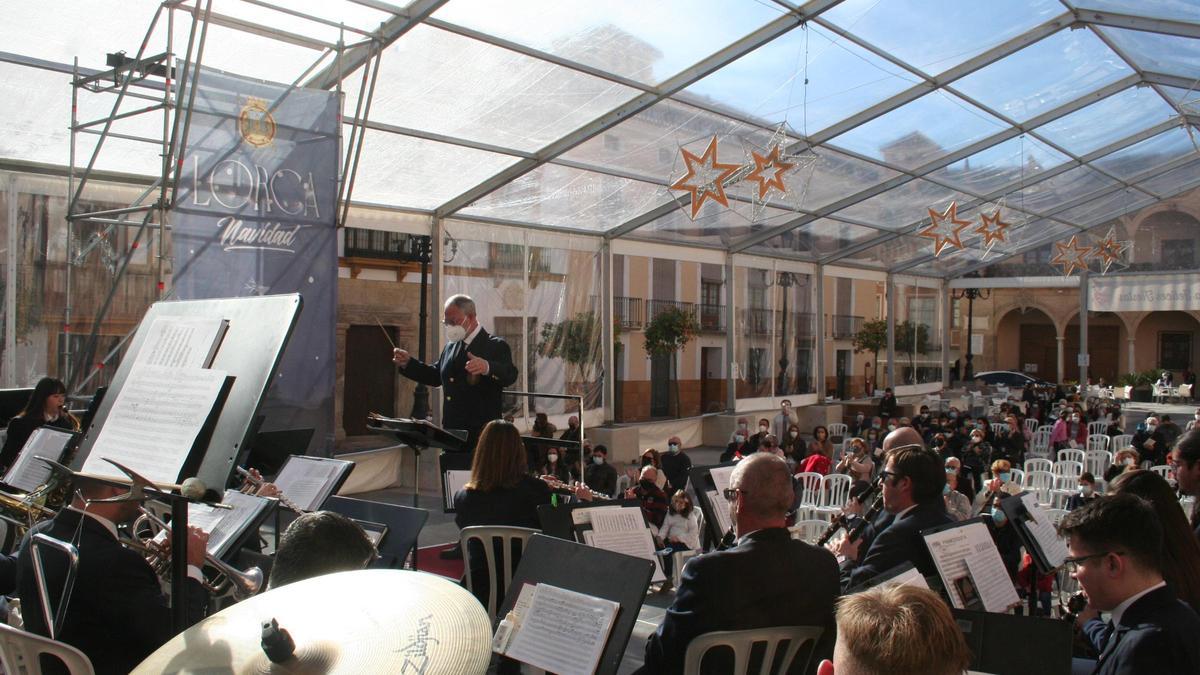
[835,441,954,589]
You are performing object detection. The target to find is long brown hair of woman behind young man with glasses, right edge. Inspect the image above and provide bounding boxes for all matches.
[1102,468,1200,608]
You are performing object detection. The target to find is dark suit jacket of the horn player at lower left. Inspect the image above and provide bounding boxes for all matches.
[17,509,208,674]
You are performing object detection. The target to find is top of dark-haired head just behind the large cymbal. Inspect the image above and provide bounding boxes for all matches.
[269,510,377,589]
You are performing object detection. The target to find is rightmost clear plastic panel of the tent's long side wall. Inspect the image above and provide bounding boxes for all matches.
[894,276,946,387]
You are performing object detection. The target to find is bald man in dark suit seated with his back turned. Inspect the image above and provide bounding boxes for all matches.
[638,453,839,674]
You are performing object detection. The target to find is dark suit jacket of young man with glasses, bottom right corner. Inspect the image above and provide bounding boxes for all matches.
[1088,587,1200,675]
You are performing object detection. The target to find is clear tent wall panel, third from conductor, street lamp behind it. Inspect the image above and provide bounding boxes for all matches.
[734,261,820,407]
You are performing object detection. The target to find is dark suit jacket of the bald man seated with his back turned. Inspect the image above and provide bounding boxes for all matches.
[638,527,839,675]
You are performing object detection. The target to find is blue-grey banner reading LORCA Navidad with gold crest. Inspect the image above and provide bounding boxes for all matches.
[170,68,341,454]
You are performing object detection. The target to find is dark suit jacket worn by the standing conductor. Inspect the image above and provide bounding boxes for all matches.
[400,329,517,447]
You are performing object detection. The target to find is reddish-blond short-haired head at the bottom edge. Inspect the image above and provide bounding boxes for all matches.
[817,586,971,675]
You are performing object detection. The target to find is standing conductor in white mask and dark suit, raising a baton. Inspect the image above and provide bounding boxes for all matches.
[391,295,517,448]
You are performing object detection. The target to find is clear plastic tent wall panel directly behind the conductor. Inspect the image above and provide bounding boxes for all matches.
[444,221,605,430]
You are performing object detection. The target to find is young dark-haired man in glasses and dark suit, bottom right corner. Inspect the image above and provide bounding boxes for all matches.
[1058,494,1200,675]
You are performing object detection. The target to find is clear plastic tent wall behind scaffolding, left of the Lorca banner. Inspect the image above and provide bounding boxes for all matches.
[0,173,170,395]
